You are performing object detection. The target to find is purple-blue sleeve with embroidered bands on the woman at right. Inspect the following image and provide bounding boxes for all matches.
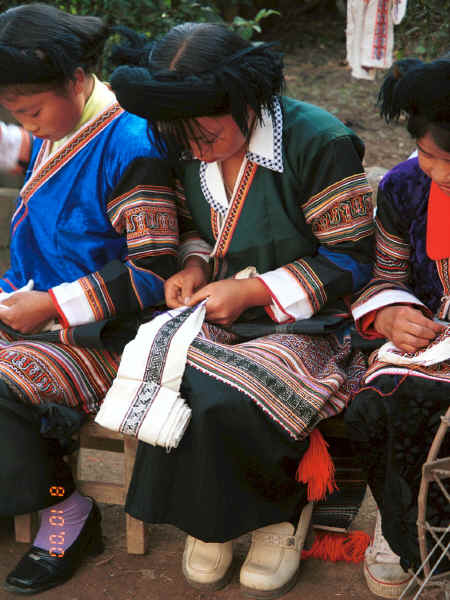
[352,158,443,337]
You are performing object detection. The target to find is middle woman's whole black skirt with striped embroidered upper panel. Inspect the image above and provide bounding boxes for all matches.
[126,324,365,542]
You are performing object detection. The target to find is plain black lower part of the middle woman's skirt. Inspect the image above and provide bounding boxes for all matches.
[125,366,309,542]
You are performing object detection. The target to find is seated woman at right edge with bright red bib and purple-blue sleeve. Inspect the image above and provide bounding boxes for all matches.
[346,58,450,598]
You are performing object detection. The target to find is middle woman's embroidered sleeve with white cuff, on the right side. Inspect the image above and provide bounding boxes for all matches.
[261,137,373,322]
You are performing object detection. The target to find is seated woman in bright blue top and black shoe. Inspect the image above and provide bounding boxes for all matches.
[0,4,178,594]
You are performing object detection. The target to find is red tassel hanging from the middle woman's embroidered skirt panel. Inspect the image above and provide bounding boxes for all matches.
[295,429,338,502]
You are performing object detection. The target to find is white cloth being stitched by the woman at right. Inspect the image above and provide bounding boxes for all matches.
[378,326,450,367]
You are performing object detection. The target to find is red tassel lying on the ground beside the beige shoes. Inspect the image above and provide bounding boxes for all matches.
[302,531,371,563]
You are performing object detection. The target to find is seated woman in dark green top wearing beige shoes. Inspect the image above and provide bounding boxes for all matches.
[111,23,372,597]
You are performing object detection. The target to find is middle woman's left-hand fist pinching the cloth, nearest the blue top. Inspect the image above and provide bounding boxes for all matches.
[164,256,209,308]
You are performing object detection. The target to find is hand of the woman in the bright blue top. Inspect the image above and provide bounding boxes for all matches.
[0,292,58,333]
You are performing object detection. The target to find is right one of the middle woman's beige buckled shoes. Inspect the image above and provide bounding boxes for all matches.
[240,502,313,600]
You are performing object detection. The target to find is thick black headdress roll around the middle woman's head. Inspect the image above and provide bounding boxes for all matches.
[111,35,283,129]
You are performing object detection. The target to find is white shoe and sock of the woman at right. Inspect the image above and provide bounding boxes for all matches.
[364,511,412,598]
